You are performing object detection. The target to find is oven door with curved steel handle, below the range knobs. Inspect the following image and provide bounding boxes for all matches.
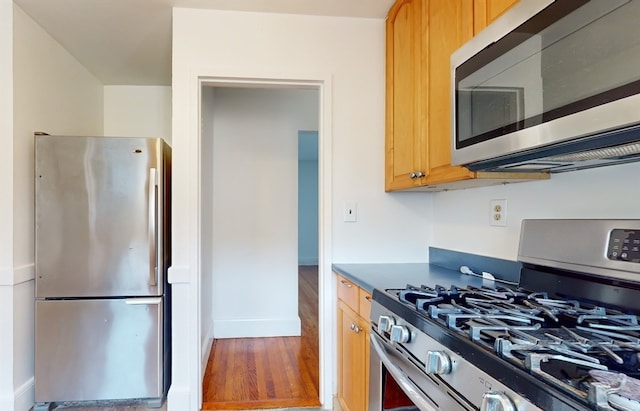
[369,329,474,411]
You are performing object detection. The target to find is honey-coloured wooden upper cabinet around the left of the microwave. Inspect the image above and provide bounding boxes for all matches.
[385,0,548,191]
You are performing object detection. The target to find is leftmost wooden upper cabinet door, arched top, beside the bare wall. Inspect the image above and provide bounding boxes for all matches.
[385,0,427,191]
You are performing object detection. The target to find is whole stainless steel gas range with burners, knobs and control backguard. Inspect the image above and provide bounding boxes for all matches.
[371,220,640,411]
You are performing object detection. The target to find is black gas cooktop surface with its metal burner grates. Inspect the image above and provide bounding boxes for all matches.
[388,278,640,410]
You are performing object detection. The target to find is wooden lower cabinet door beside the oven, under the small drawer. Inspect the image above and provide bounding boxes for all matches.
[338,302,368,411]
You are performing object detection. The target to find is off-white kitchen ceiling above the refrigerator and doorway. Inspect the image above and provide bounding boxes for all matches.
[14,0,393,85]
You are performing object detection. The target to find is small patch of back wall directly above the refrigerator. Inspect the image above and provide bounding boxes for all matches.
[104,86,171,144]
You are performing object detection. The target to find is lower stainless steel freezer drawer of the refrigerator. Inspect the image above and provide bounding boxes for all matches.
[35,297,167,403]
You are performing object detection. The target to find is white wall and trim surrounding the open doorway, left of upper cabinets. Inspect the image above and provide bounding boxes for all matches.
[169,9,431,409]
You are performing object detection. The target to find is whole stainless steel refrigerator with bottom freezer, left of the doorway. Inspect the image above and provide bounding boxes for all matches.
[35,135,171,409]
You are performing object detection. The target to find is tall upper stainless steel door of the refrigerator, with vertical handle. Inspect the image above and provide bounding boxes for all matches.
[35,136,166,298]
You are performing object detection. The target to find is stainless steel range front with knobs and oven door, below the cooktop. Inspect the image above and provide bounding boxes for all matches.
[369,301,540,411]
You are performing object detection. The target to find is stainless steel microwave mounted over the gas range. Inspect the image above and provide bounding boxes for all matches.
[451,0,640,172]
